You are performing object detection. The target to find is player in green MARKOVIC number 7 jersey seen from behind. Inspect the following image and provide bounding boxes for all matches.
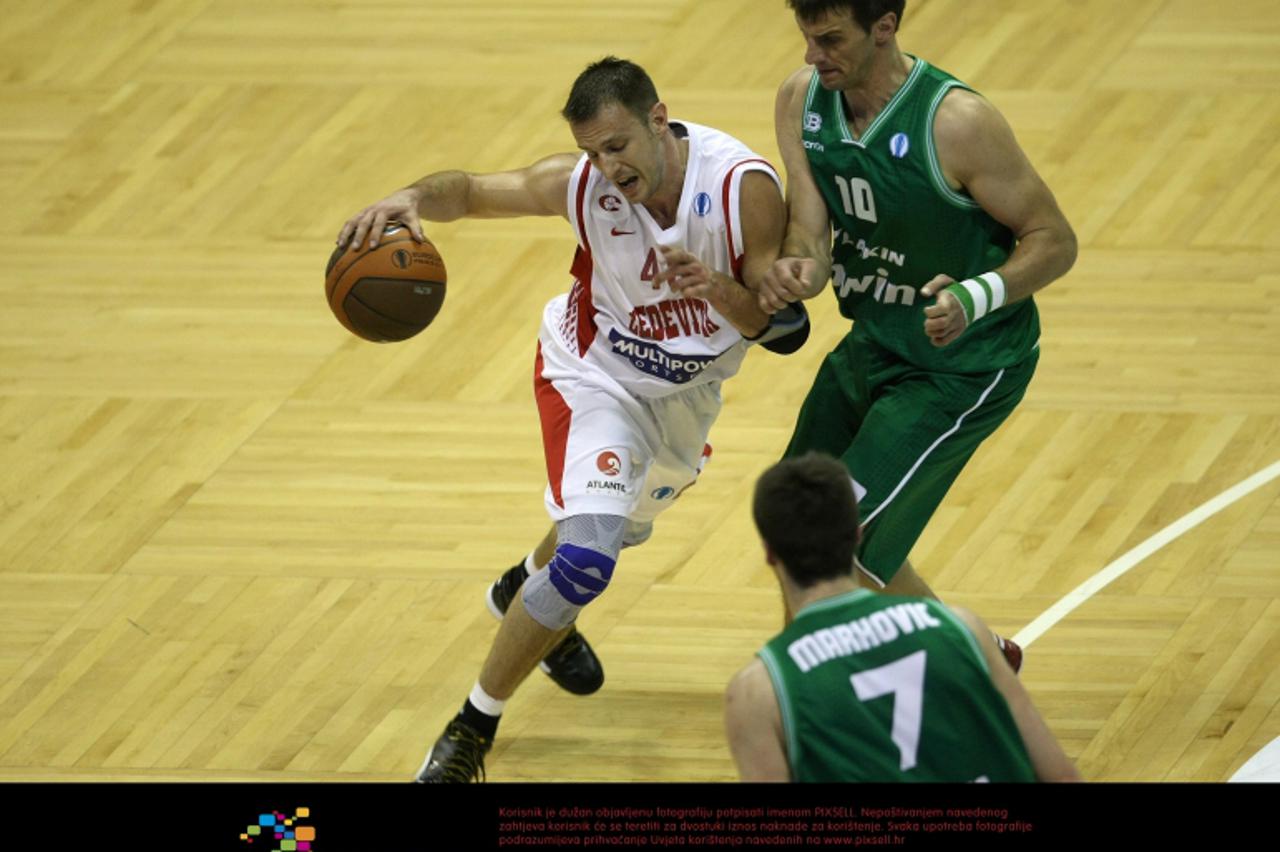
[724,453,1079,782]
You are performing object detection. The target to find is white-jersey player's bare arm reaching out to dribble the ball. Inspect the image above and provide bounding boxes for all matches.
[338,154,580,247]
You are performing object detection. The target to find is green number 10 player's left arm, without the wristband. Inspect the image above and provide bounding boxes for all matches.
[749,67,831,313]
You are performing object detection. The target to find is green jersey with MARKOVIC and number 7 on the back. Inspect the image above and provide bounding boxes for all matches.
[760,588,1036,782]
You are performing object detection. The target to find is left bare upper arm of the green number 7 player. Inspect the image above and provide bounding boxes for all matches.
[724,658,791,782]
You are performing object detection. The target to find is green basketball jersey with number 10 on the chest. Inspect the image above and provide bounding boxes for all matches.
[803,59,1039,372]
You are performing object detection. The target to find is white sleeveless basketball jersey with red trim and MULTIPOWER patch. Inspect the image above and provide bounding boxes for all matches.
[547,122,782,397]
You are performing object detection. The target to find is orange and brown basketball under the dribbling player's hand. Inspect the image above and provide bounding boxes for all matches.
[324,223,445,343]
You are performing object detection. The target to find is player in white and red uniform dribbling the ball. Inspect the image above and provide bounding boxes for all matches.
[338,58,808,782]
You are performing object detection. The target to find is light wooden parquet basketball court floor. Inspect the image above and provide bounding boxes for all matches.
[0,0,1280,780]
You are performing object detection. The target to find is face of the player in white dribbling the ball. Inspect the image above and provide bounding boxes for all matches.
[570,104,667,205]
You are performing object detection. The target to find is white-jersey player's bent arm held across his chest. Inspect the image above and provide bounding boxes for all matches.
[653,170,787,339]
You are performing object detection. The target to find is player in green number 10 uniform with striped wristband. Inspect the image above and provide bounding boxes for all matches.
[759,0,1076,669]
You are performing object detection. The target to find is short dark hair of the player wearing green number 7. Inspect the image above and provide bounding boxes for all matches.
[751,453,859,587]
